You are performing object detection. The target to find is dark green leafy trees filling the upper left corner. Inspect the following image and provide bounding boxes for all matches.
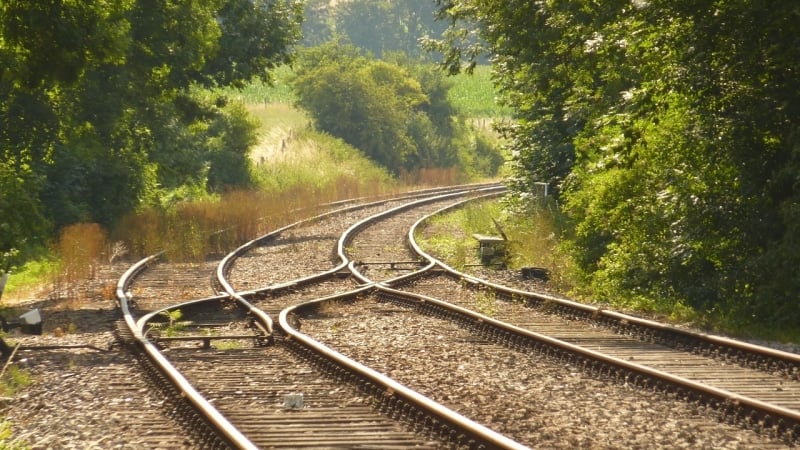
[0,0,302,266]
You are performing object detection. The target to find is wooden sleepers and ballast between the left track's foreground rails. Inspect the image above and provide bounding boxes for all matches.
[168,345,439,449]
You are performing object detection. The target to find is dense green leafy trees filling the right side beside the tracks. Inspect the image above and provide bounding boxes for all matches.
[429,0,800,328]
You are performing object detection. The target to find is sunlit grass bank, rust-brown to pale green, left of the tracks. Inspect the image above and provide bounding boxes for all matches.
[37,87,476,295]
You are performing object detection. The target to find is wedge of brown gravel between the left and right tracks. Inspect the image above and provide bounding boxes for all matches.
[301,299,783,449]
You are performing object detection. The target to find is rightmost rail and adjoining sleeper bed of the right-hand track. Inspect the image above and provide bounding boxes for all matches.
[409,199,800,400]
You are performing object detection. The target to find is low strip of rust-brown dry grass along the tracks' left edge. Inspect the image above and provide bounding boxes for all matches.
[36,173,406,303]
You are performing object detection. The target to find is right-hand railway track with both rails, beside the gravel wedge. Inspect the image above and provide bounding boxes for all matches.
[368,192,800,442]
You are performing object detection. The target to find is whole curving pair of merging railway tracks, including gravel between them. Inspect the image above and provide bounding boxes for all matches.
[108,186,800,448]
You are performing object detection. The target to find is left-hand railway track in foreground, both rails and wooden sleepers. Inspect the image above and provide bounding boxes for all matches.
[118,185,516,448]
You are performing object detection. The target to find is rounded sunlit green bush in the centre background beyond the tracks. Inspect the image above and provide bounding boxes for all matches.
[292,42,503,176]
